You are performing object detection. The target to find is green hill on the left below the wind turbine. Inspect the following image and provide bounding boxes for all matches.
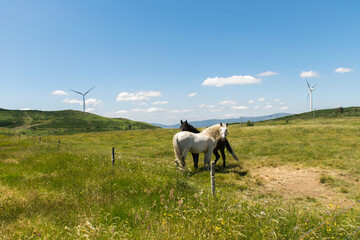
[0,108,157,135]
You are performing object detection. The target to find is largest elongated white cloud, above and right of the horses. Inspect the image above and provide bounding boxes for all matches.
[202,75,261,87]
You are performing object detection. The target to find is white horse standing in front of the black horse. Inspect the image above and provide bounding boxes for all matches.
[173,123,228,170]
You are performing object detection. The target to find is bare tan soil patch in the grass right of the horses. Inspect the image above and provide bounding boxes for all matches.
[252,166,353,206]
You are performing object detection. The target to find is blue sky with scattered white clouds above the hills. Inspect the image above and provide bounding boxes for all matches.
[0,0,360,124]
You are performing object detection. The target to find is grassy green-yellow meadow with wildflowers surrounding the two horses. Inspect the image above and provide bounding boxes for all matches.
[0,114,360,240]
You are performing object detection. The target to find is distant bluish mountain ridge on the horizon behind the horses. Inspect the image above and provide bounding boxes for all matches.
[151,113,291,128]
